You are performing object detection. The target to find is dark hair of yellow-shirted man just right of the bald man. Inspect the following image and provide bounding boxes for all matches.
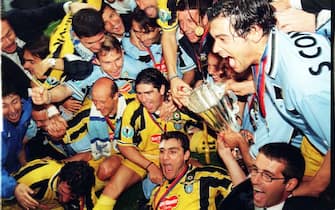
[135,68,170,94]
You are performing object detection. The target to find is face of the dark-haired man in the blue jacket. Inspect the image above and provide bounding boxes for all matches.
[2,94,22,123]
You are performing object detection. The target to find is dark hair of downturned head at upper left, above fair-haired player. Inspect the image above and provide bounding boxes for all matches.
[72,8,105,38]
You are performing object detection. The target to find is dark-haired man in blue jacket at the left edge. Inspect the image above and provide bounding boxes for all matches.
[1,80,36,207]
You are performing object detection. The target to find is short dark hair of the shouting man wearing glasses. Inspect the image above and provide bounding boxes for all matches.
[259,143,305,183]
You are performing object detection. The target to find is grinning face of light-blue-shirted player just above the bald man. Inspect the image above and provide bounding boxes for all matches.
[99,50,123,79]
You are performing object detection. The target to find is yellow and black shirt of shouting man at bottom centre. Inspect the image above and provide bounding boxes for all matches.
[150,166,232,210]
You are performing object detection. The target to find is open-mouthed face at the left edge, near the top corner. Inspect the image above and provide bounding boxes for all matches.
[1,20,17,53]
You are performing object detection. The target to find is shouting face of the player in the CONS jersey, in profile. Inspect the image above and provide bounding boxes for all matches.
[210,17,258,72]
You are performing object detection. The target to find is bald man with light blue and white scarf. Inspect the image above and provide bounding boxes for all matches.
[88,77,135,181]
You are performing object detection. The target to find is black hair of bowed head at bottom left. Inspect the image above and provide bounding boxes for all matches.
[58,161,95,199]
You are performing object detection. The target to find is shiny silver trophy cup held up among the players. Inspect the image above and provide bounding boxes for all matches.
[186,83,240,132]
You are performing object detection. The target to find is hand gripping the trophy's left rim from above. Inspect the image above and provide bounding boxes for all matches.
[170,77,192,107]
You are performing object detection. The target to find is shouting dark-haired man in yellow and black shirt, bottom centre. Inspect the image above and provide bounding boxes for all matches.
[150,131,232,210]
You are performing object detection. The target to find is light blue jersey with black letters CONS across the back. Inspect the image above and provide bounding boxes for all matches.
[253,30,331,154]
